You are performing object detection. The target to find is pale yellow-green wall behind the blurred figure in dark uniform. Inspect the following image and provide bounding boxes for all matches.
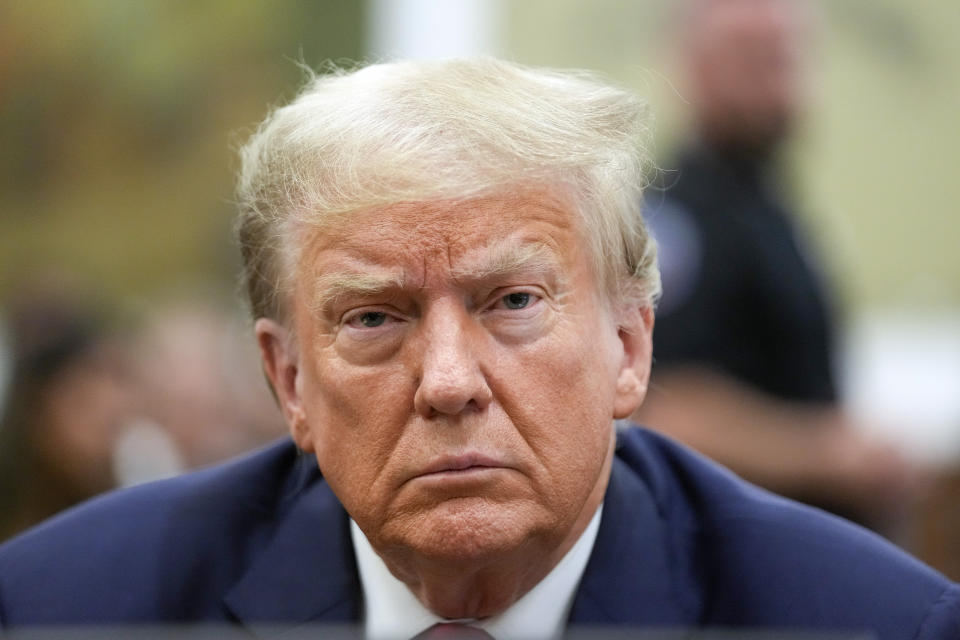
[506,0,960,309]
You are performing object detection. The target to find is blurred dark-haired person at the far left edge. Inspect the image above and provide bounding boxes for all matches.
[0,292,133,539]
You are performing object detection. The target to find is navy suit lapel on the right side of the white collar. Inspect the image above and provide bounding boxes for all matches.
[570,436,697,626]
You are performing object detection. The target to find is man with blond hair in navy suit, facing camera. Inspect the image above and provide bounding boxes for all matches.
[0,59,960,638]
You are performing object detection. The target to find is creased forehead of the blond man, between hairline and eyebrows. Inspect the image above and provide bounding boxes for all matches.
[301,189,585,278]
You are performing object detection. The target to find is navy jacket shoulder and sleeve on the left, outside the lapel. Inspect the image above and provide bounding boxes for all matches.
[0,441,306,625]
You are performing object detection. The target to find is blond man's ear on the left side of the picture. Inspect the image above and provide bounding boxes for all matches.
[254,318,313,452]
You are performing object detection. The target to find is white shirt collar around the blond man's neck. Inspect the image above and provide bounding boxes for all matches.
[350,504,603,640]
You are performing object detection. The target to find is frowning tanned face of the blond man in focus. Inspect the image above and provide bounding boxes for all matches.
[258,190,650,561]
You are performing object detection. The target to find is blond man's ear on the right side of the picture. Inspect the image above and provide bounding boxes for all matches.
[613,307,653,420]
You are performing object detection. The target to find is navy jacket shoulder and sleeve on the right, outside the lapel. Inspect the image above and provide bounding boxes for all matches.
[617,428,960,639]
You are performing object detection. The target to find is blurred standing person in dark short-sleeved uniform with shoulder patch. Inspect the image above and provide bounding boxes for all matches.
[639,0,919,528]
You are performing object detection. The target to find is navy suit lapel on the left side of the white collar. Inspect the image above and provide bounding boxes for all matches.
[224,456,361,626]
